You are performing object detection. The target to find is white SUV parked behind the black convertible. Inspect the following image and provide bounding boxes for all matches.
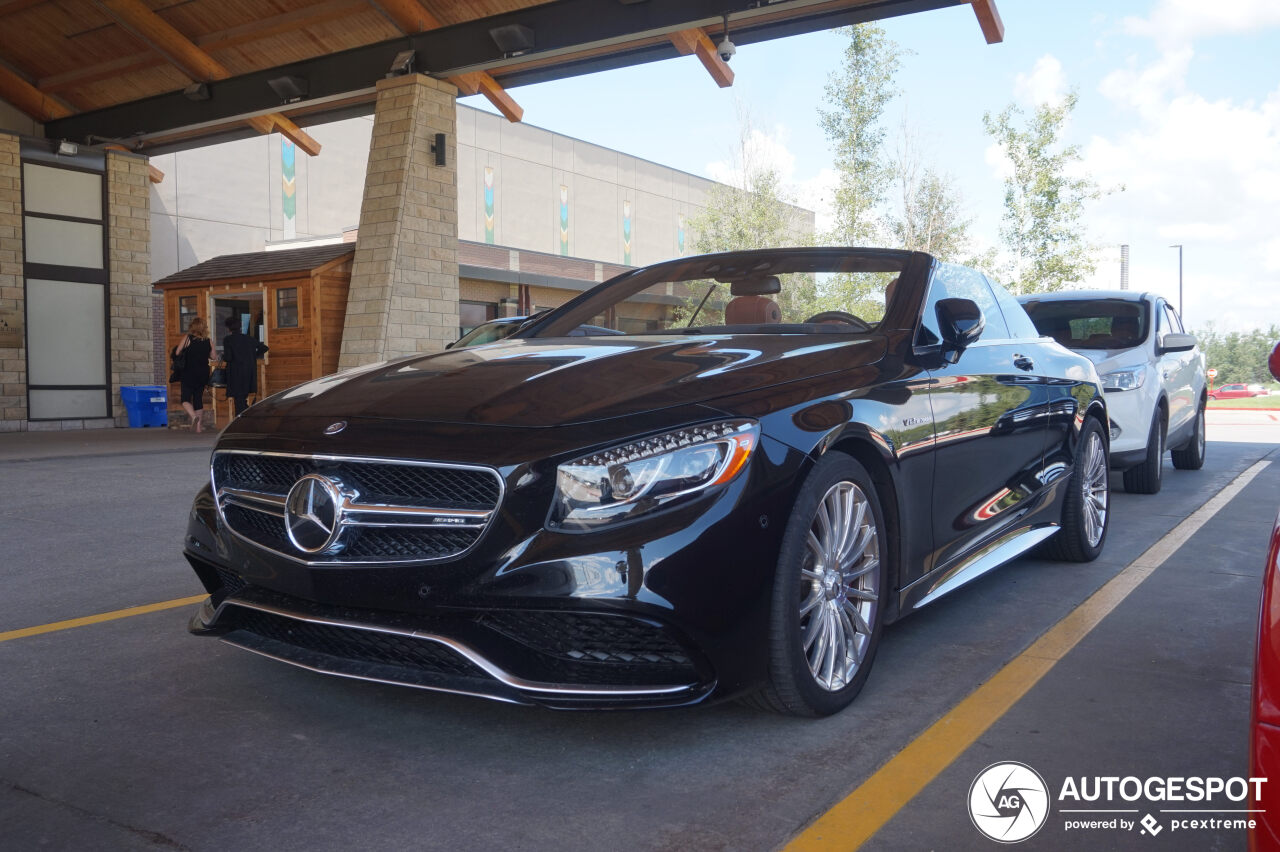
[1018,290,1207,494]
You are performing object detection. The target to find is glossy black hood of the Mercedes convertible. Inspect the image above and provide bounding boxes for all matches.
[248,334,884,427]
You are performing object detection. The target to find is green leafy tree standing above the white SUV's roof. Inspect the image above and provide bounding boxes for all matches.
[982,92,1102,293]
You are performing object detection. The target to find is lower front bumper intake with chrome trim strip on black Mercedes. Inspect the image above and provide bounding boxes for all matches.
[191,580,714,709]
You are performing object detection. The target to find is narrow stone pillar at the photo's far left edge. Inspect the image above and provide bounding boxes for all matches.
[0,133,27,431]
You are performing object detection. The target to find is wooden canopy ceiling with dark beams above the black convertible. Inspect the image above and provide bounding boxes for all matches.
[0,0,1004,155]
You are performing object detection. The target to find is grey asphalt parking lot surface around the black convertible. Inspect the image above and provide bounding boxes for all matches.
[0,412,1280,849]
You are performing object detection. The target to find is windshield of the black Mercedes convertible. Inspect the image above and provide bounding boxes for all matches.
[532,249,909,338]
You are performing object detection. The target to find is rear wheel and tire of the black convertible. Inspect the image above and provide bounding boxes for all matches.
[1044,417,1111,562]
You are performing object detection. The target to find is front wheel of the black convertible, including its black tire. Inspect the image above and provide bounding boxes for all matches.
[755,452,890,716]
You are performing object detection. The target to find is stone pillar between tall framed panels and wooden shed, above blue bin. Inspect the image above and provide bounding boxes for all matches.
[106,151,155,426]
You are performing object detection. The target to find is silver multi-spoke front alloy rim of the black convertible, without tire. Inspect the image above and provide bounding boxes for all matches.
[800,481,881,692]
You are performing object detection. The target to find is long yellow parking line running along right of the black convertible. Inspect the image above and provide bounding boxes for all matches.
[785,462,1271,852]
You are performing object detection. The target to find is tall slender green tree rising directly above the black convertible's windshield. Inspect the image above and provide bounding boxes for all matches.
[819,24,902,246]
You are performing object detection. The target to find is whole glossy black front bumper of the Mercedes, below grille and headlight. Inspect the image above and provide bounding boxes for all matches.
[184,427,808,709]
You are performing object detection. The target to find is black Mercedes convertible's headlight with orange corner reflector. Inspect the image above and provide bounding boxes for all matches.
[549,420,760,530]
